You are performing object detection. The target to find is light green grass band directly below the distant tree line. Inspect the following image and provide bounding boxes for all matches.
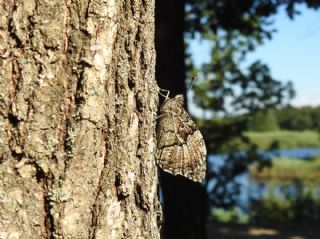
[245,130,320,150]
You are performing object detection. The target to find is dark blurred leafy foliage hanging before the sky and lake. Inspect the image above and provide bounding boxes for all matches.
[185,0,320,209]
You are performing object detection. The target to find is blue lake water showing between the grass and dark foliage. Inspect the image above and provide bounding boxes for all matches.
[209,148,320,211]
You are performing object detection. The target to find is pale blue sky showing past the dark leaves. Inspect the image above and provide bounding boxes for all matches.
[191,4,320,106]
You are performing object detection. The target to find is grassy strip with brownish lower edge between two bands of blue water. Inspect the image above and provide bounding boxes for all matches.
[249,157,320,180]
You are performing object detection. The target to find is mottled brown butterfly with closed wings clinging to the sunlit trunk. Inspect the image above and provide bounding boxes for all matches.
[156,95,207,182]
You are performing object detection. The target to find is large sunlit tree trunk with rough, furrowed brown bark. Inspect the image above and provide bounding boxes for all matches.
[0,0,161,239]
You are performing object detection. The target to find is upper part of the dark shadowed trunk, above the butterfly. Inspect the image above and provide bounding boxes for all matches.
[155,0,186,96]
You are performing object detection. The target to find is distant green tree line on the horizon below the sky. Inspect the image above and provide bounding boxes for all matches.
[248,105,320,131]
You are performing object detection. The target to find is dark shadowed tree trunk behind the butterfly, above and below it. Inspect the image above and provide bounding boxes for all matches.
[156,0,208,239]
